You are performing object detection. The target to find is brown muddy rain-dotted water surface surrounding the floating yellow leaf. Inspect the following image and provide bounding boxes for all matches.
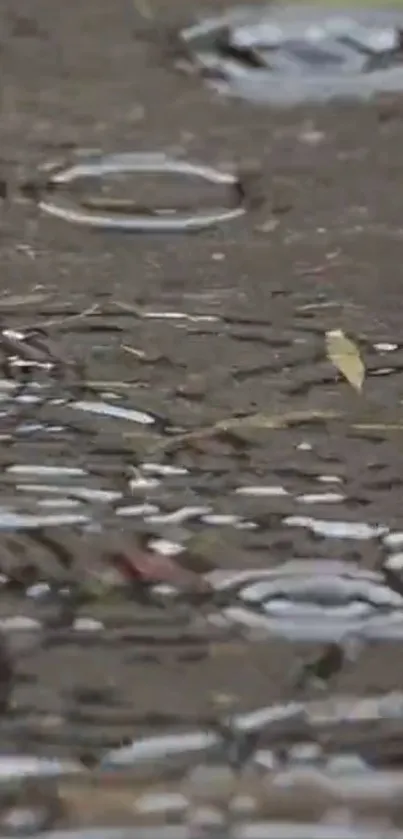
[0,0,403,839]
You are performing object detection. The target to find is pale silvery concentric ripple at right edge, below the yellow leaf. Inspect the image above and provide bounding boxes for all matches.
[208,560,403,642]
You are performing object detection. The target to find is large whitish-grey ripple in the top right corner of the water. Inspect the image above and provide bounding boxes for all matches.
[180,5,403,107]
